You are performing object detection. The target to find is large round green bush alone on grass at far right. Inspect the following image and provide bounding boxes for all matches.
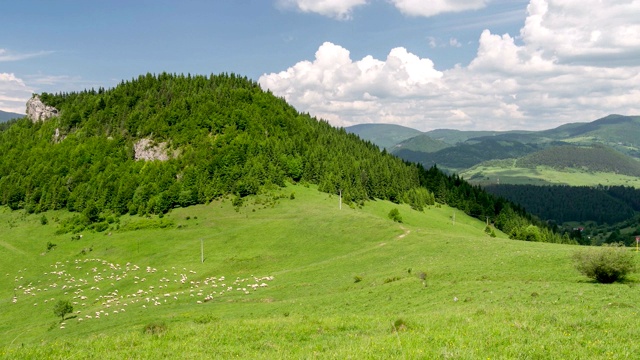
[573,243,635,284]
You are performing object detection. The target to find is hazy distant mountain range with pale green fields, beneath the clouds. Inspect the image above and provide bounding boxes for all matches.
[346,115,640,187]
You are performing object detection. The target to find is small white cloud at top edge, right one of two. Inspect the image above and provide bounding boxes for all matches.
[390,0,487,17]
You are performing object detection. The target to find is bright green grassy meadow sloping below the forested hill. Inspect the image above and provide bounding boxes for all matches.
[0,185,640,359]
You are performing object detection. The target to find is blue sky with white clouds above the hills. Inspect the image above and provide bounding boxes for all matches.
[0,0,640,130]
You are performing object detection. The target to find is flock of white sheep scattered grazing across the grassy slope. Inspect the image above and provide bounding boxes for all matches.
[12,258,274,329]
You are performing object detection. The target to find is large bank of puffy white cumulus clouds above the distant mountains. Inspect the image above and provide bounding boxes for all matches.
[259,0,640,130]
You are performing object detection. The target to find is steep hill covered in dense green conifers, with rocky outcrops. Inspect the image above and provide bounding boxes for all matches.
[0,73,566,242]
